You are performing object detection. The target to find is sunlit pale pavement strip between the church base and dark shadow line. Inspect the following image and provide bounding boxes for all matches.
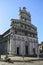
[1,55,43,62]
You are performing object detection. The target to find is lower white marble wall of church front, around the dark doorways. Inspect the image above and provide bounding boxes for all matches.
[10,34,38,55]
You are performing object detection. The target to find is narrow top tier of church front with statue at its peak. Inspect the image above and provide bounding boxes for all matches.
[19,7,31,22]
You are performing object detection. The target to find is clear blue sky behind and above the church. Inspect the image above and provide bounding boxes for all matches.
[0,0,43,43]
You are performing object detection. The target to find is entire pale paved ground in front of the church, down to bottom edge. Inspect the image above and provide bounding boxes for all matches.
[0,55,43,65]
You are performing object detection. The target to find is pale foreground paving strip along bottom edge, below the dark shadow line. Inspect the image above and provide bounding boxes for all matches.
[0,61,43,65]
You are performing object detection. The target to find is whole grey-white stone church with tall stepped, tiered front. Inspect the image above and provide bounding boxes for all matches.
[0,7,38,56]
